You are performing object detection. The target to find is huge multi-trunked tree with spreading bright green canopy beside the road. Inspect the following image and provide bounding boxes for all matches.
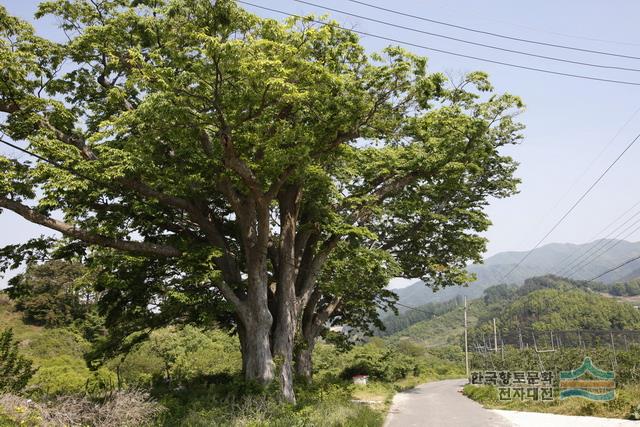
[0,0,522,400]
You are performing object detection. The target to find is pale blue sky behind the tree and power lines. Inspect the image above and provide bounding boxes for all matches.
[0,0,640,280]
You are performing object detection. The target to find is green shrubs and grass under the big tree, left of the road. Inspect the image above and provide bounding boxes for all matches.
[0,301,463,427]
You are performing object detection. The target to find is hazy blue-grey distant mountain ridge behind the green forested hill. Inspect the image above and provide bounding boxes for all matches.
[395,239,640,311]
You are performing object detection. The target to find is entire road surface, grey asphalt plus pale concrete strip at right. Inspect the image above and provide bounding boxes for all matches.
[385,379,640,427]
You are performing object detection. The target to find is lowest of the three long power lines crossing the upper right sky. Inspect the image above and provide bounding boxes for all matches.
[238,0,640,86]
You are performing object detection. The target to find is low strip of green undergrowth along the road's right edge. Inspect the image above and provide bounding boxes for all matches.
[464,384,640,419]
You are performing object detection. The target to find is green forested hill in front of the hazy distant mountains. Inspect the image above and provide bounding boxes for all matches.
[380,275,640,347]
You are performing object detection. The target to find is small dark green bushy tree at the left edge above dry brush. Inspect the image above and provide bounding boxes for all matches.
[0,329,36,393]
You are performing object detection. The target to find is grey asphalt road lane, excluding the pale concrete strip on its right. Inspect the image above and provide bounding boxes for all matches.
[385,379,512,427]
